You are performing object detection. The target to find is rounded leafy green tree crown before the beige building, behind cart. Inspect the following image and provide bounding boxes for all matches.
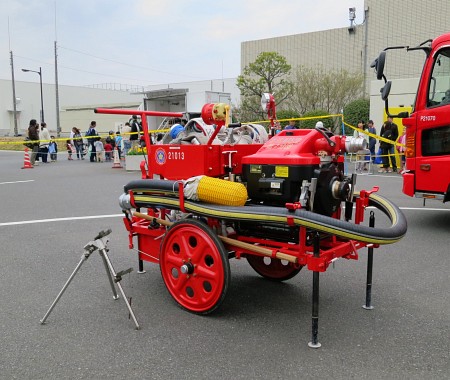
[236,52,292,121]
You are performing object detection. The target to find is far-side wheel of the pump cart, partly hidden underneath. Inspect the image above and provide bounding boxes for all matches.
[246,255,303,281]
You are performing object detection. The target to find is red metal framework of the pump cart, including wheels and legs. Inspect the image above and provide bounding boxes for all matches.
[96,105,408,348]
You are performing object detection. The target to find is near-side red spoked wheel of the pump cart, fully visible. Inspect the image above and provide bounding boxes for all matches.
[159,219,230,314]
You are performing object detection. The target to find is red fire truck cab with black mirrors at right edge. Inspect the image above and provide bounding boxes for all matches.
[372,33,450,202]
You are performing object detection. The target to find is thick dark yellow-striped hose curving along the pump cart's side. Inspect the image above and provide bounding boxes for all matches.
[125,180,407,244]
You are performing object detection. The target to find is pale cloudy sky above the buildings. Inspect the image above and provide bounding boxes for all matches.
[0,0,364,86]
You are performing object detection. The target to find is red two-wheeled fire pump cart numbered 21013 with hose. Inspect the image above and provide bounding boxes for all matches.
[96,94,406,348]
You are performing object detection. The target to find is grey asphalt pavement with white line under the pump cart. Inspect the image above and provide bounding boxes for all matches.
[0,151,450,379]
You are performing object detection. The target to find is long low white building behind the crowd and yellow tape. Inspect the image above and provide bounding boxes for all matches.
[0,78,239,136]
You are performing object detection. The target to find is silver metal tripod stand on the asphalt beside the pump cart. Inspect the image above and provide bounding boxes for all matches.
[41,229,140,330]
